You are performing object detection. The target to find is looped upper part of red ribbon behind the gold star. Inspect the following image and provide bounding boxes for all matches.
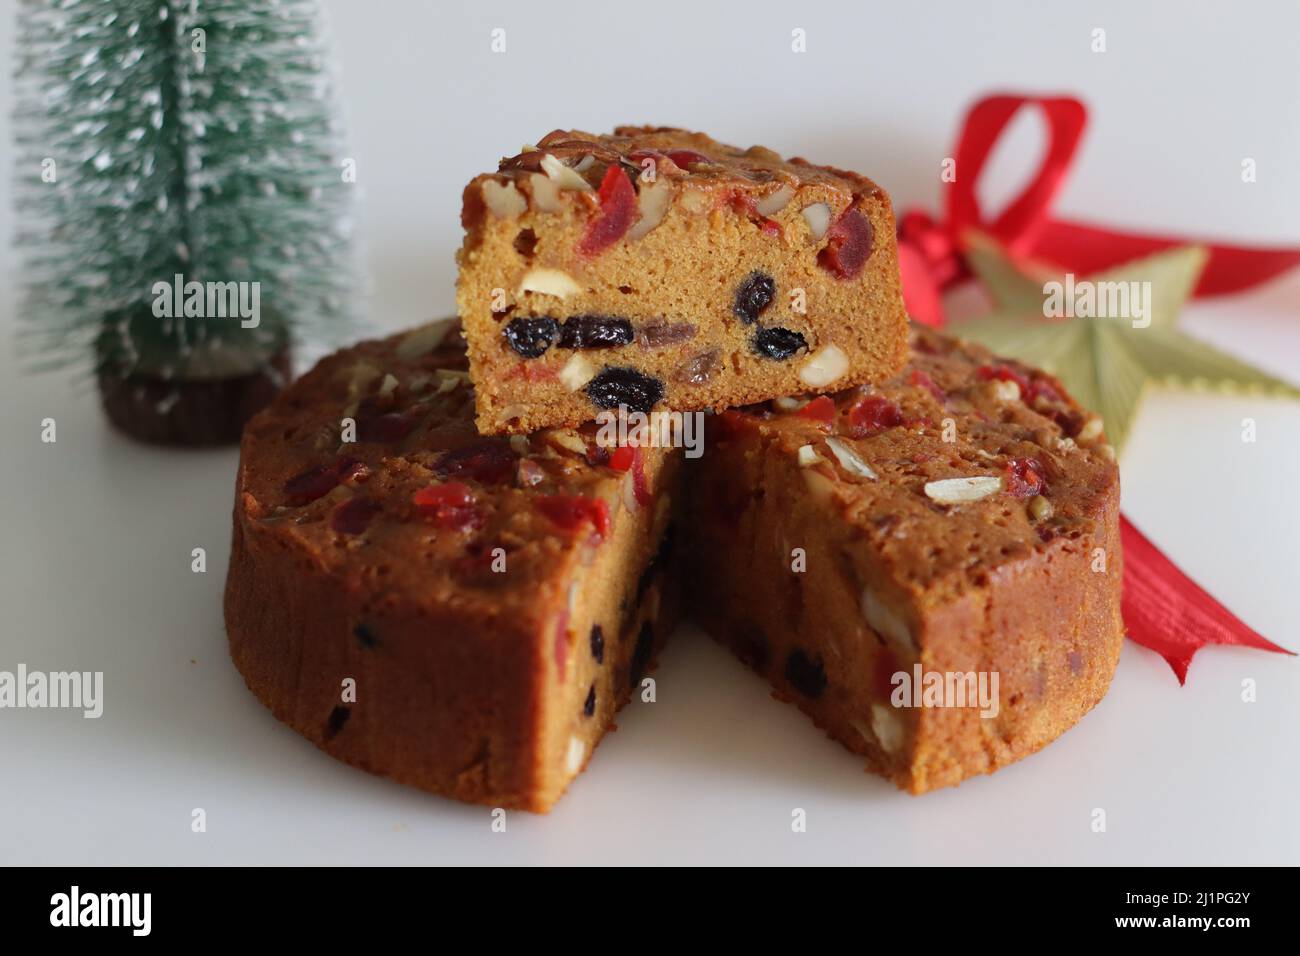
[898,95,1300,326]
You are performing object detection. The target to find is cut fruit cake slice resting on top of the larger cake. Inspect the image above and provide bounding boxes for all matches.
[456,126,907,434]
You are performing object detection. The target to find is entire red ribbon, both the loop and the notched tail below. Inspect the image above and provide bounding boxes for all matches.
[898,95,1300,683]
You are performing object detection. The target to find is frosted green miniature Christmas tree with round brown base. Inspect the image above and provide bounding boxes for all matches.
[16,0,352,444]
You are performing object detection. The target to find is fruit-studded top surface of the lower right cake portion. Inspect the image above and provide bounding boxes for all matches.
[706,326,1119,593]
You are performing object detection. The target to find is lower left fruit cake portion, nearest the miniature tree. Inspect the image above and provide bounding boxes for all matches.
[225,317,681,812]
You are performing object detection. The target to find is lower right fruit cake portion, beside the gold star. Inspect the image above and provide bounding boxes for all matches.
[686,329,1123,793]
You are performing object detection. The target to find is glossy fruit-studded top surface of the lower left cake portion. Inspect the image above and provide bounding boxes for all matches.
[239,323,662,613]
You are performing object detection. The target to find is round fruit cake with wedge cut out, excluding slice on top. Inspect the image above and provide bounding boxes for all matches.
[225,317,1123,810]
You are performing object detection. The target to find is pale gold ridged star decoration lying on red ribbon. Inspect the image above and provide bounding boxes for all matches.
[953,238,1300,449]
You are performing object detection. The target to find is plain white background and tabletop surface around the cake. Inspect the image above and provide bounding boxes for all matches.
[0,0,1300,864]
